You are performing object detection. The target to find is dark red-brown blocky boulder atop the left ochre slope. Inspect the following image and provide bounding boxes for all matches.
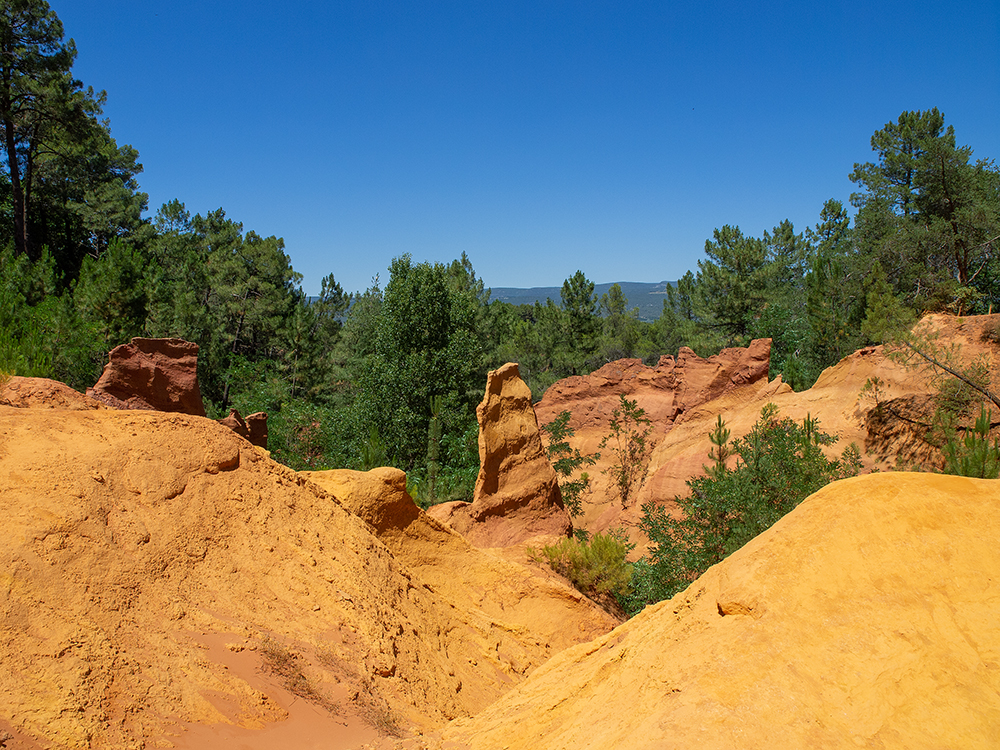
[87,338,205,417]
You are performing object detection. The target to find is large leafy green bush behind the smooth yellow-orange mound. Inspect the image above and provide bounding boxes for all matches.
[627,404,861,613]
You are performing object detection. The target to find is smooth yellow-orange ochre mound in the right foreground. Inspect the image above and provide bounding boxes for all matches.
[430,473,1000,750]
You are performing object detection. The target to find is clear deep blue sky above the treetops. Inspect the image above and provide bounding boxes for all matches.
[50,0,1000,294]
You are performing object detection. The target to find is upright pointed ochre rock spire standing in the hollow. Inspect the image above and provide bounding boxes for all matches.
[430,363,572,547]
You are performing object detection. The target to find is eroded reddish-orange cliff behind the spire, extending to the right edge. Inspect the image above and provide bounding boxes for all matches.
[536,315,1000,555]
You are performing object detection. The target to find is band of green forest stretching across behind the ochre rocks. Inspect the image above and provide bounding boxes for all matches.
[0,0,1000,504]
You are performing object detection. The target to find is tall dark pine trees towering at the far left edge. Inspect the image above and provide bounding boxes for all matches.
[0,0,146,281]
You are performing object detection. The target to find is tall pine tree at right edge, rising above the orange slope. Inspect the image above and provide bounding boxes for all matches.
[851,108,1000,315]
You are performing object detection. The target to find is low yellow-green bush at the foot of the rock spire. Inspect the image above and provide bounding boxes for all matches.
[531,529,635,607]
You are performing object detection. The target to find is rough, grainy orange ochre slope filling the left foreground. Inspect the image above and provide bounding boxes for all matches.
[0,406,614,748]
